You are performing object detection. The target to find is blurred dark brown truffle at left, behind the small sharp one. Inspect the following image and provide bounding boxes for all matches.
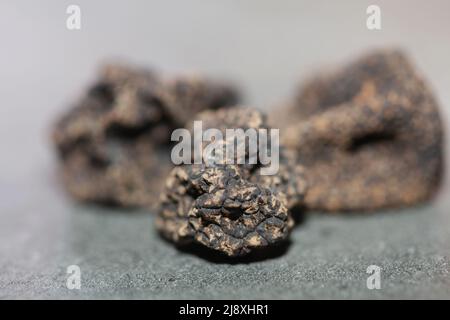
[53,65,237,206]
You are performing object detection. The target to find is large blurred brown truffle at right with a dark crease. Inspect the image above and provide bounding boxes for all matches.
[282,51,443,211]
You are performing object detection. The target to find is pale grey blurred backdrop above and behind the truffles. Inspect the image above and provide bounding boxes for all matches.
[0,0,450,196]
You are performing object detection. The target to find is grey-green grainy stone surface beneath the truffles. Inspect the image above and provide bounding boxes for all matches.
[0,161,450,299]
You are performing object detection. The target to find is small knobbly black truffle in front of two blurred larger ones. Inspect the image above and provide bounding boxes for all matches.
[156,108,306,256]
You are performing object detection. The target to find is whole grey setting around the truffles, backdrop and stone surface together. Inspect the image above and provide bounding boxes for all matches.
[0,0,450,298]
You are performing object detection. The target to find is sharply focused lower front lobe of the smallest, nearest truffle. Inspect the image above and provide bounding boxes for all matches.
[157,165,293,256]
